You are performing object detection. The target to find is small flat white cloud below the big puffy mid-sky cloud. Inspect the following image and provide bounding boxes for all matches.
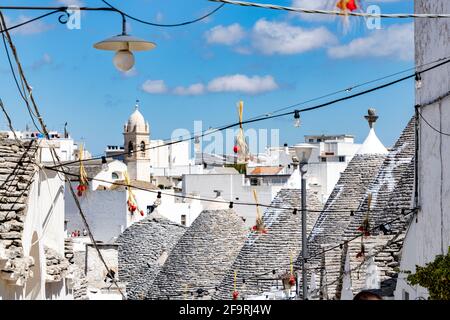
[208,74,278,94]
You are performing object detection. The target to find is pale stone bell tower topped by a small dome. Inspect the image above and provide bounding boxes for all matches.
[123,100,150,181]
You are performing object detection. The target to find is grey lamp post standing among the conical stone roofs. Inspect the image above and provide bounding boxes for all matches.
[294,143,317,300]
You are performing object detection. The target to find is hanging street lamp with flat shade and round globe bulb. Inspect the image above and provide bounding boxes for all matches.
[94,14,156,72]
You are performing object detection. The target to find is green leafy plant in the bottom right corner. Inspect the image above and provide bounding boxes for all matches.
[406,248,450,300]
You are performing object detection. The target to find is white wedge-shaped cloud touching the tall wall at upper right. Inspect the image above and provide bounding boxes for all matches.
[328,23,414,60]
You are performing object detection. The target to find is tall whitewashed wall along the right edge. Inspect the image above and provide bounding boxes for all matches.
[395,0,450,300]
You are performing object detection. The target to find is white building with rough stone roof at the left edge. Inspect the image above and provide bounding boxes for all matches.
[0,138,72,300]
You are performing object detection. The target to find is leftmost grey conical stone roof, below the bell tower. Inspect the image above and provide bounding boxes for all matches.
[116,212,186,299]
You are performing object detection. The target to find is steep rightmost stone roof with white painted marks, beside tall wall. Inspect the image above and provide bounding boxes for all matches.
[330,118,415,296]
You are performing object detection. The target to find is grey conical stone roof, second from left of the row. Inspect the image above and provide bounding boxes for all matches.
[148,209,247,299]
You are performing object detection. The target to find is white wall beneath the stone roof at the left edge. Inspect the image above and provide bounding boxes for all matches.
[0,170,71,300]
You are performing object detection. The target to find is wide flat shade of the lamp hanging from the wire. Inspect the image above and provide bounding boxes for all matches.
[94,34,156,51]
